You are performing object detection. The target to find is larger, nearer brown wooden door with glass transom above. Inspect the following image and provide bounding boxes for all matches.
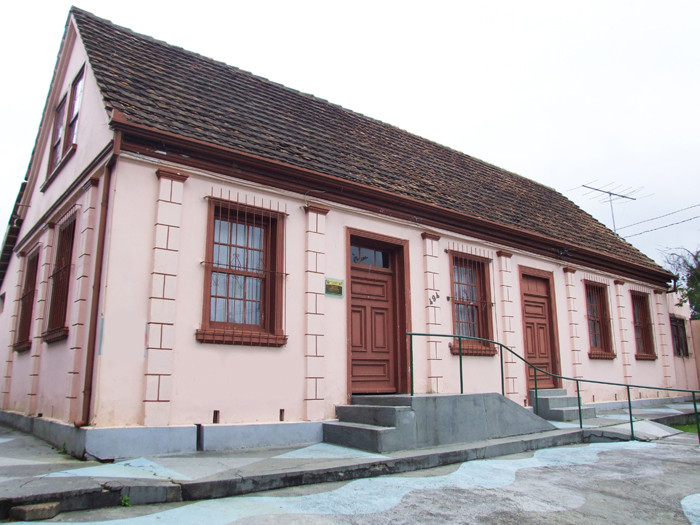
[350,246,398,394]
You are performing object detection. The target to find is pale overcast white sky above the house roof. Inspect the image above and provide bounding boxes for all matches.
[0,0,700,263]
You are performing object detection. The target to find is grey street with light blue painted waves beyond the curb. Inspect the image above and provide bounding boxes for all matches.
[21,434,700,525]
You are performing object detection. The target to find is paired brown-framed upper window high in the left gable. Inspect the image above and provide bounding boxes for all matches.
[49,68,85,177]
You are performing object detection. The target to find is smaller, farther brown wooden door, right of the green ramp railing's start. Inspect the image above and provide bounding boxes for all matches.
[520,275,558,388]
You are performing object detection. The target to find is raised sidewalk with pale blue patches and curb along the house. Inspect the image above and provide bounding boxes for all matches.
[0,403,697,520]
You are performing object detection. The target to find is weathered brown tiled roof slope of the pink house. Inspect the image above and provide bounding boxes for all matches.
[71,8,661,271]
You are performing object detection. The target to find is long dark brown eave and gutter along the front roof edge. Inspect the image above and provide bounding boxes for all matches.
[111,110,673,290]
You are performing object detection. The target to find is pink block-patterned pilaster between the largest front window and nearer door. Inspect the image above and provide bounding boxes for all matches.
[304,204,330,421]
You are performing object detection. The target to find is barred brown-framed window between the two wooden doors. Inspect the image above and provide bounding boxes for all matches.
[450,252,496,355]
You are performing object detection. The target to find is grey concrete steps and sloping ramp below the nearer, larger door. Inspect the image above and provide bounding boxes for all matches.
[323,394,555,453]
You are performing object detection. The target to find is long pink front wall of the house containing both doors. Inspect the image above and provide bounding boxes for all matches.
[85,155,691,426]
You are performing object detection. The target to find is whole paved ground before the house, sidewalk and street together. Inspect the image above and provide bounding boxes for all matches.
[0,404,700,525]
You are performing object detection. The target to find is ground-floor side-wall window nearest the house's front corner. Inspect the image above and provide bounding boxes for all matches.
[41,214,76,343]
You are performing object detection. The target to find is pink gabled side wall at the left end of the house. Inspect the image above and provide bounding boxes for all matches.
[1,22,112,421]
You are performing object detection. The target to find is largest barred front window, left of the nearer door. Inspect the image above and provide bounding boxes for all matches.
[196,199,287,346]
